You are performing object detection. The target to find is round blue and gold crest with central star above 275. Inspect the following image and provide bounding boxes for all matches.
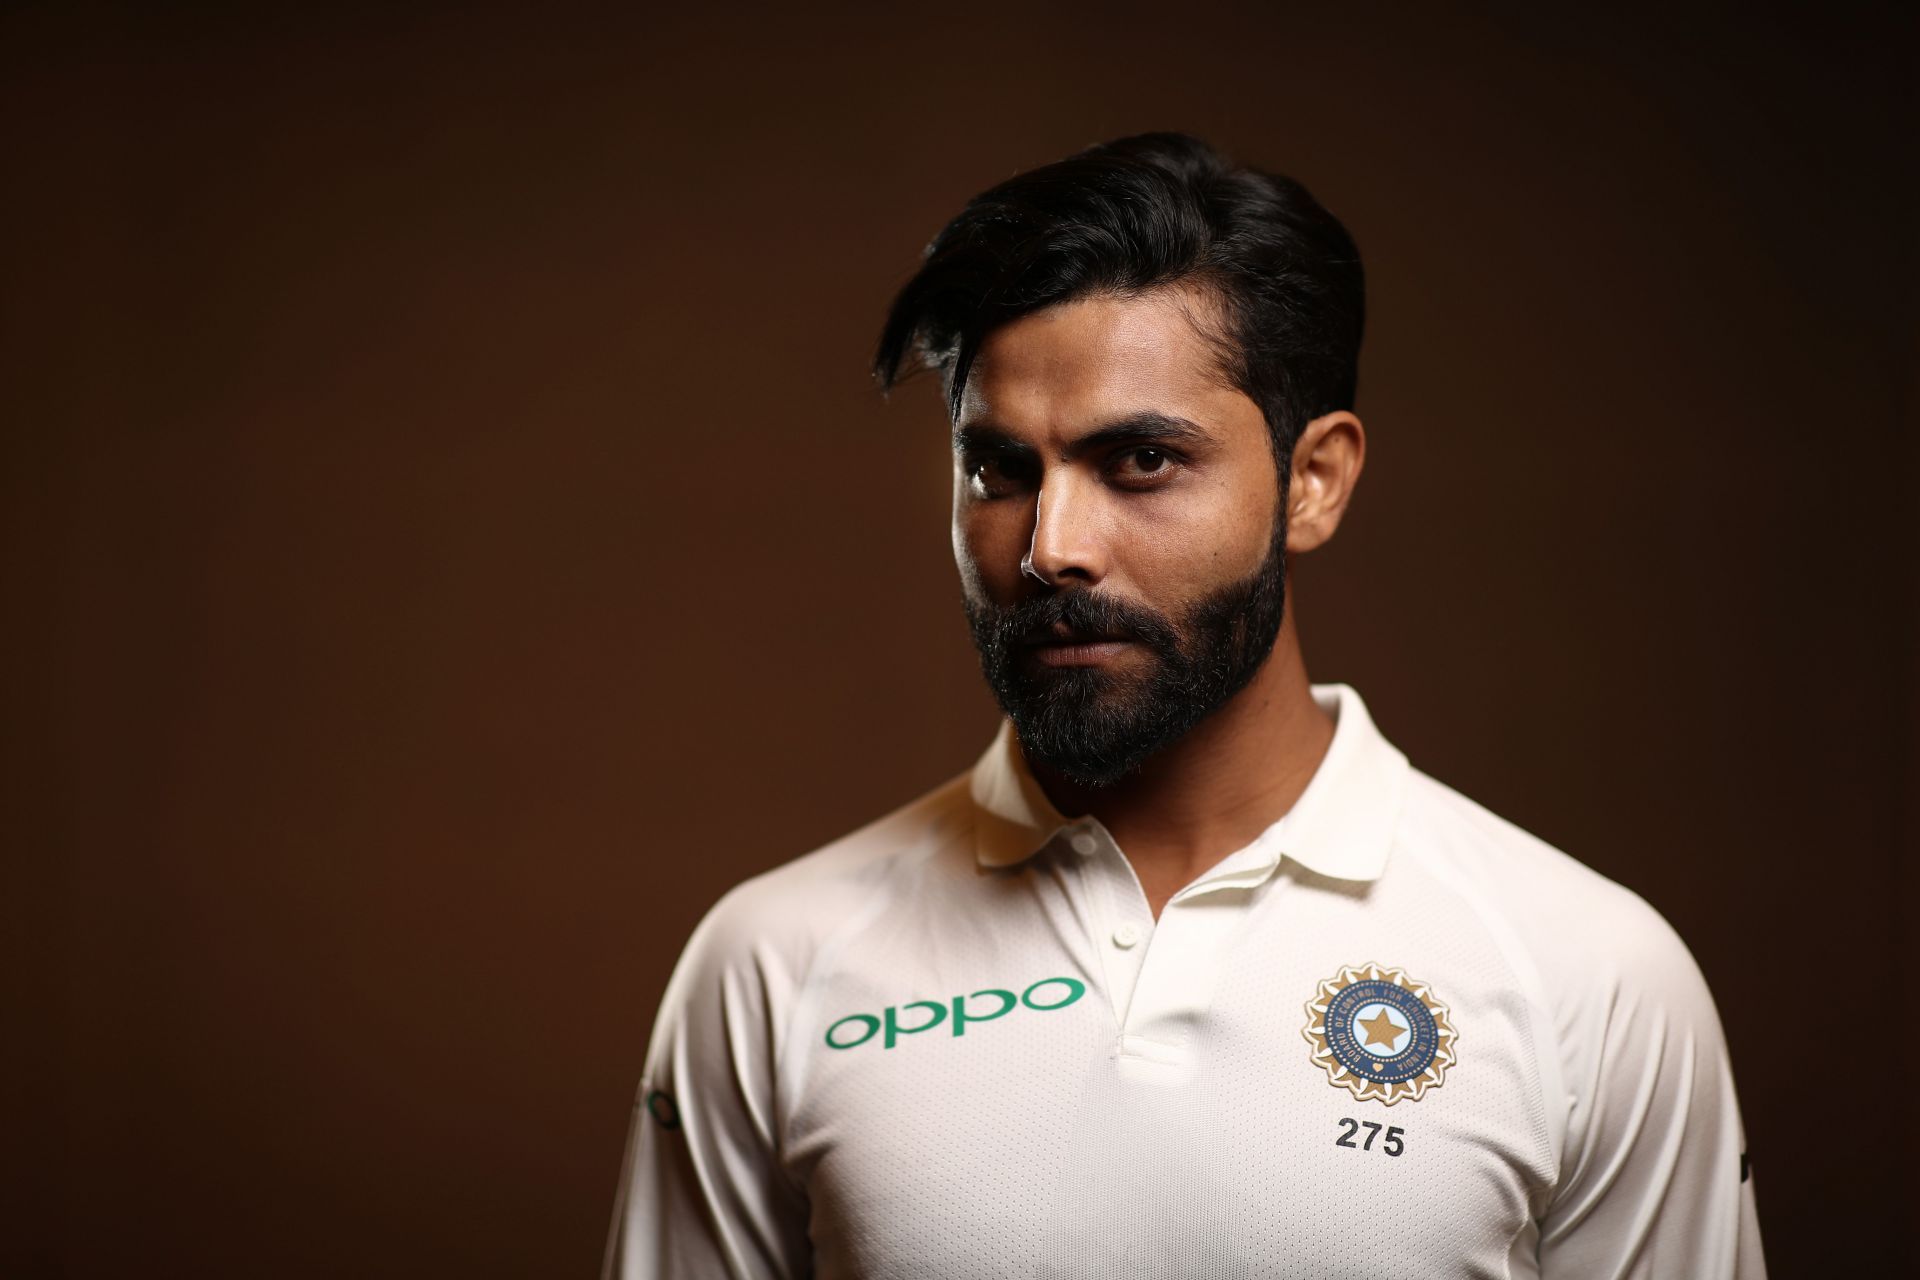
[1302,963,1459,1107]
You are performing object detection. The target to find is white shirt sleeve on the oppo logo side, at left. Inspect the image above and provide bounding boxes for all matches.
[601,887,812,1280]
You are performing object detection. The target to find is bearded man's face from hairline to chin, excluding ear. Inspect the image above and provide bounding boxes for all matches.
[952,290,1286,787]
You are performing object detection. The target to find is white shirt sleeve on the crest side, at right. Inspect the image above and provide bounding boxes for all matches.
[1540,900,1766,1280]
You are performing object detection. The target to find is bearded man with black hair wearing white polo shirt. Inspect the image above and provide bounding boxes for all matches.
[607,134,1763,1280]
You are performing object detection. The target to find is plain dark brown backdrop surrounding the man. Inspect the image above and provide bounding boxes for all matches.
[0,4,1920,1276]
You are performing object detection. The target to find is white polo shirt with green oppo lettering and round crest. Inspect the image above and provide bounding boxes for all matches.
[605,685,1764,1280]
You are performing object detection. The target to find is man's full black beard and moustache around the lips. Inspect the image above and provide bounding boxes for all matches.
[964,495,1286,787]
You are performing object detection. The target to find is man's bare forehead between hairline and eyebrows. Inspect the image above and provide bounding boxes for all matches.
[954,290,1265,436]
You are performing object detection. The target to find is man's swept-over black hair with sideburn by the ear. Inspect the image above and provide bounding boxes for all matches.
[874,132,1365,474]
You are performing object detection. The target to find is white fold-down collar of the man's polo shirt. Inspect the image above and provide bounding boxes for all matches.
[970,683,1411,889]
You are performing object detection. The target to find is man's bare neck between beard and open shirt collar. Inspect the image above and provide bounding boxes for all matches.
[1033,601,1332,919]
